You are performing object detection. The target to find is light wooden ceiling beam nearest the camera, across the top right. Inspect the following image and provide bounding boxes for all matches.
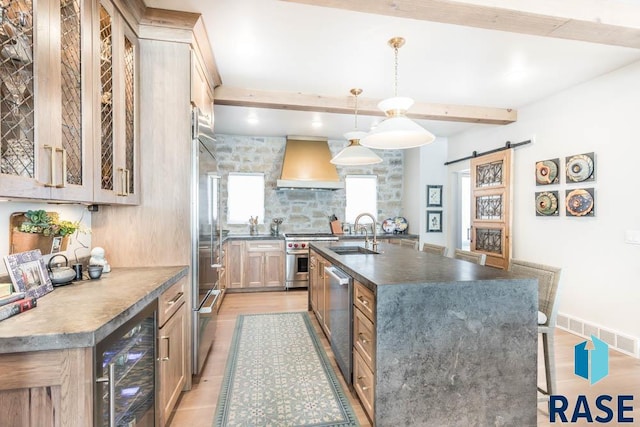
[282,0,640,49]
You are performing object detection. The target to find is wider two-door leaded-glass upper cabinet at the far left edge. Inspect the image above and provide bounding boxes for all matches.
[0,0,93,201]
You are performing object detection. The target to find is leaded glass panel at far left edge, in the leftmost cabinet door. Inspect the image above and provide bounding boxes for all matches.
[0,0,35,178]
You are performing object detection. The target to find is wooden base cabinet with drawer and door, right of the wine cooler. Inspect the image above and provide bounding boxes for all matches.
[156,279,189,426]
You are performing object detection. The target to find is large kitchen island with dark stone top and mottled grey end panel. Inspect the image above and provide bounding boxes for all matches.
[311,242,538,426]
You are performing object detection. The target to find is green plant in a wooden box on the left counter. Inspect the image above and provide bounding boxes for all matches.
[10,209,87,254]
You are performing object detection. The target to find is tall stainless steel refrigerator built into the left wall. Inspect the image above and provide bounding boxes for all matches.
[191,107,223,374]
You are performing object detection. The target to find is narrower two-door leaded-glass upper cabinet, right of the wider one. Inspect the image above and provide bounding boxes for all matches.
[94,1,140,204]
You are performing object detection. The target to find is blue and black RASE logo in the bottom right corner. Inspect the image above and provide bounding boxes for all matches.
[549,335,633,424]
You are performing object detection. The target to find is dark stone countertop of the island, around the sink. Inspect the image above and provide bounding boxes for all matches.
[311,241,519,292]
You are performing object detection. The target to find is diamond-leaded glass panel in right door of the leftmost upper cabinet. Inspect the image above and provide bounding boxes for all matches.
[60,0,82,185]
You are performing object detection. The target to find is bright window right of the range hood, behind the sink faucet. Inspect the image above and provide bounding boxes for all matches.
[344,175,378,223]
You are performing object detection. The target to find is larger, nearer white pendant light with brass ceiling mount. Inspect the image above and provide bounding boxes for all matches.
[361,37,436,150]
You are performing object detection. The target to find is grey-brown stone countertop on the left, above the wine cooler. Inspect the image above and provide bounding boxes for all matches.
[0,266,188,354]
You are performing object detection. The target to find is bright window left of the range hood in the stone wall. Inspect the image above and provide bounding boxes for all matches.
[227,173,264,224]
